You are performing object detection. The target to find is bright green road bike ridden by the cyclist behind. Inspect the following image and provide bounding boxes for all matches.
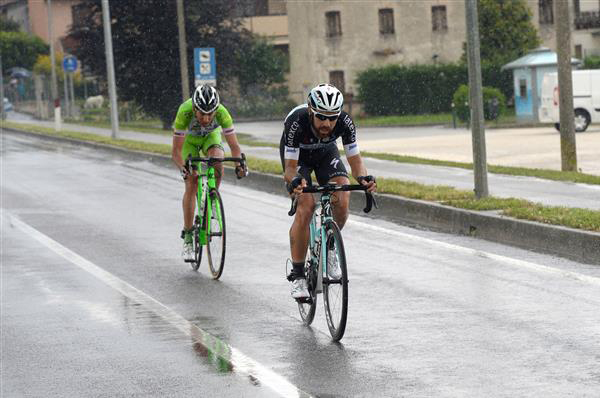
[185,154,246,279]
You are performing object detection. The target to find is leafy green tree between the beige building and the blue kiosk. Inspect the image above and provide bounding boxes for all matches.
[463,0,540,65]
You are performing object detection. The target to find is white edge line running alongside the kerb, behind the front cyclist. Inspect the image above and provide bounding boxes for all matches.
[227,187,600,286]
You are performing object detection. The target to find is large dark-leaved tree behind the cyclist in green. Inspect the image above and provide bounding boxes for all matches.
[70,0,252,127]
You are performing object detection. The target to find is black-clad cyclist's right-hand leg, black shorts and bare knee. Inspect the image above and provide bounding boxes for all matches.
[315,146,350,229]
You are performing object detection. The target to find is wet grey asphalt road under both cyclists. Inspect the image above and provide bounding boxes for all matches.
[1,134,600,397]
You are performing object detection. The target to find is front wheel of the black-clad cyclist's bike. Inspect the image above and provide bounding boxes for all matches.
[322,221,348,341]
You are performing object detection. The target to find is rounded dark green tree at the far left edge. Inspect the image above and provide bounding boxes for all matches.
[0,32,48,70]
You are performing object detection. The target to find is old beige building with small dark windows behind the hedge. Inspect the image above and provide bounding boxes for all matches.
[286,0,600,102]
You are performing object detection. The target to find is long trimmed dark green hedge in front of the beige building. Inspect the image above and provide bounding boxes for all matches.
[356,64,513,115]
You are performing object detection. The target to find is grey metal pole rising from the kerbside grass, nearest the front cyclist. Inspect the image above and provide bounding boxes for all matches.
[465,0,489,199]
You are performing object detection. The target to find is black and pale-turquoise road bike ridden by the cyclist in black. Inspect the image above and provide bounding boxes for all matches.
[288,185,377,341]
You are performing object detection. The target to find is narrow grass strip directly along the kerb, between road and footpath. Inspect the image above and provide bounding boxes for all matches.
[2,122,600,232]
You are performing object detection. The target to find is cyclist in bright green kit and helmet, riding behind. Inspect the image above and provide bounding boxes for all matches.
[171,84,247,259]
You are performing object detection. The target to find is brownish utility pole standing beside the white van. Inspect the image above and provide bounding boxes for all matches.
[554,0,577,171]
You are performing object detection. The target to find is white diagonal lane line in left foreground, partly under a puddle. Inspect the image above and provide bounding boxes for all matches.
[8,215,311,398]
